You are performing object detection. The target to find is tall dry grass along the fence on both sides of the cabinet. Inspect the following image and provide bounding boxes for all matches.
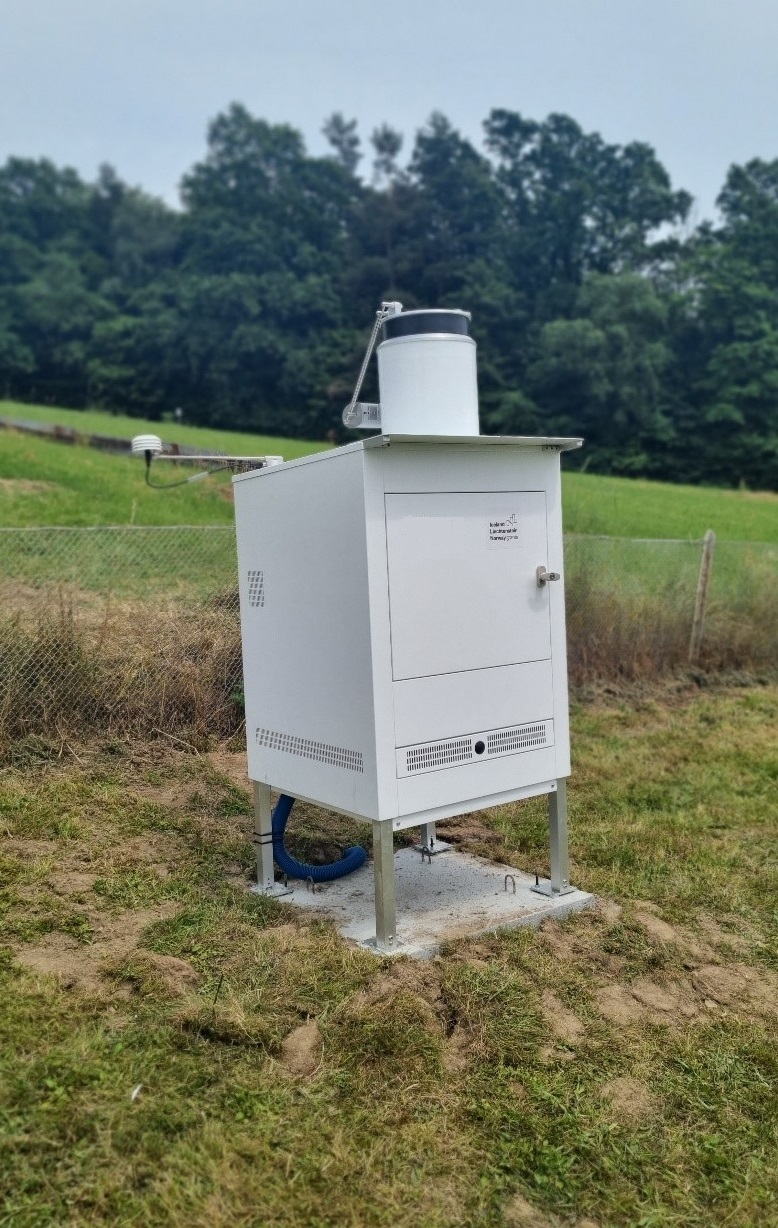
[0,567,778,744]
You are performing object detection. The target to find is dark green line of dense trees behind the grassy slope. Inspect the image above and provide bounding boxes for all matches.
[0,104,778,489]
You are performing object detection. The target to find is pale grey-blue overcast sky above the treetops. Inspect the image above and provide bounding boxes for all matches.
[0,0,778,220]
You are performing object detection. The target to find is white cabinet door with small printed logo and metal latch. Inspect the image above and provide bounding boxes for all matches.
[385,491,551,680]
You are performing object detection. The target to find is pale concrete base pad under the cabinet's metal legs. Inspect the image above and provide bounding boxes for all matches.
[269,849,594,958]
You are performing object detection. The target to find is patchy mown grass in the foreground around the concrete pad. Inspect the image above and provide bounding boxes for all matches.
[0,688,778,1228]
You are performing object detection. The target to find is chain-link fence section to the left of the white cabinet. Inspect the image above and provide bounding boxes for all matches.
[0,526,242,738]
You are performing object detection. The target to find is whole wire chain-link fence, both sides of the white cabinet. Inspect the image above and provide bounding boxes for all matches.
[0,526,778,738]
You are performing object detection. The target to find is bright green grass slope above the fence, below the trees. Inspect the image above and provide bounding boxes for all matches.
[0,402,778,542]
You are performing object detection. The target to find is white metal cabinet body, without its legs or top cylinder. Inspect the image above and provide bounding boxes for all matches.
[234,437,569,826]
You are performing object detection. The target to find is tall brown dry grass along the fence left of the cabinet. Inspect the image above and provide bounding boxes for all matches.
[0,598,242,743]
